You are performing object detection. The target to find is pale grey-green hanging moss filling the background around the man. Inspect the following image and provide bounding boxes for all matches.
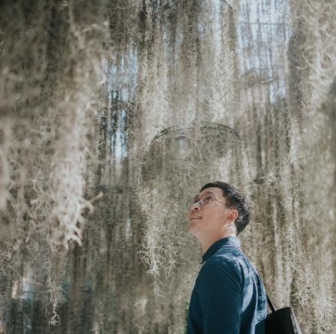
[0,0,336,333]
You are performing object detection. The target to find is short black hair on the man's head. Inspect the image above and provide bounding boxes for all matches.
[200,181,250,235]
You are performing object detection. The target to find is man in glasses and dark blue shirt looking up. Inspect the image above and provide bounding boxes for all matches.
[187,182,267,334]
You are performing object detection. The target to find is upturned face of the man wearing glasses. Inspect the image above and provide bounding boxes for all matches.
[189,187,237,240]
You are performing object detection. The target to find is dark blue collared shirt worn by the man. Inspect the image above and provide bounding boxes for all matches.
[187,237,267,334]
